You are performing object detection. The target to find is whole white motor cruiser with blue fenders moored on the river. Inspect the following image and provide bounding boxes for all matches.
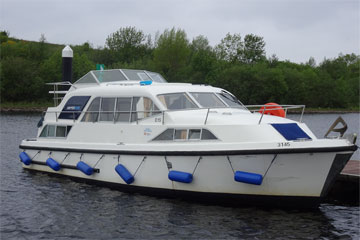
[20,69,357,206]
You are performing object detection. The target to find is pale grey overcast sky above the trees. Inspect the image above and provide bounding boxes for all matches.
[0,0,360,63]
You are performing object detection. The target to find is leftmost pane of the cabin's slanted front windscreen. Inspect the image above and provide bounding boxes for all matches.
[158,93,198,110]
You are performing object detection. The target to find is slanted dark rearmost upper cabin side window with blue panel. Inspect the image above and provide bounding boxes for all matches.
[59,96,90,119]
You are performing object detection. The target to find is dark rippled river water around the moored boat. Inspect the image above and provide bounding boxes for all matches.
[0,114,360,239]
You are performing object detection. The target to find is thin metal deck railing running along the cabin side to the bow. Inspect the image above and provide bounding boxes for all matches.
[43,105,305,125]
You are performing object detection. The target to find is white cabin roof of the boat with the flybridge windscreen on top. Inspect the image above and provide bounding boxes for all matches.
[69,69,222,96]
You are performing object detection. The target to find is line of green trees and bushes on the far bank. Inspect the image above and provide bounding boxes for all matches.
[0,27,360,109]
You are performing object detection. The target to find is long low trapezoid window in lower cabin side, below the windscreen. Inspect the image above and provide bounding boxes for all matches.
[153,128,218,141]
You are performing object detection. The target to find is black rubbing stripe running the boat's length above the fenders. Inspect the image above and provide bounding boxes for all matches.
[19,145,358,156]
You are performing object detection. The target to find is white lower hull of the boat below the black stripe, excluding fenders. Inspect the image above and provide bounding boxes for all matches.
[18,145,353,207]
